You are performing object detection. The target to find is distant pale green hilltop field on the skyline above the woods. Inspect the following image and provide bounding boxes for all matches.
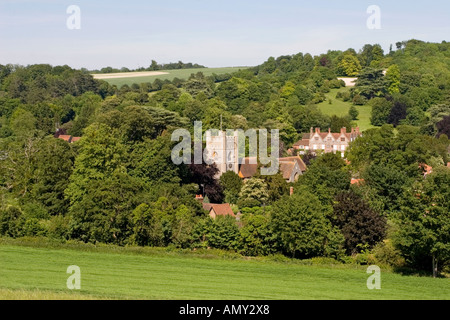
[96,67,247,88]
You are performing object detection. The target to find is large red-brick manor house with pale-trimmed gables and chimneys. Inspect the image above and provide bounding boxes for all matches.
[293,128,361,157]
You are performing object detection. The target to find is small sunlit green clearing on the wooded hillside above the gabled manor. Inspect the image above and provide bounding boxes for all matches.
[318,87,374,131]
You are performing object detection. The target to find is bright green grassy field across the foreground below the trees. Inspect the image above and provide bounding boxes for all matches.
[0,241,450,300]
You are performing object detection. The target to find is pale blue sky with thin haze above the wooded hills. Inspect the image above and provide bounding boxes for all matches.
[0,0,450,69]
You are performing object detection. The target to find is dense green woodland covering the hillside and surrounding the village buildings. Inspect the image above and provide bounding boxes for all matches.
[0,40,450,275]
